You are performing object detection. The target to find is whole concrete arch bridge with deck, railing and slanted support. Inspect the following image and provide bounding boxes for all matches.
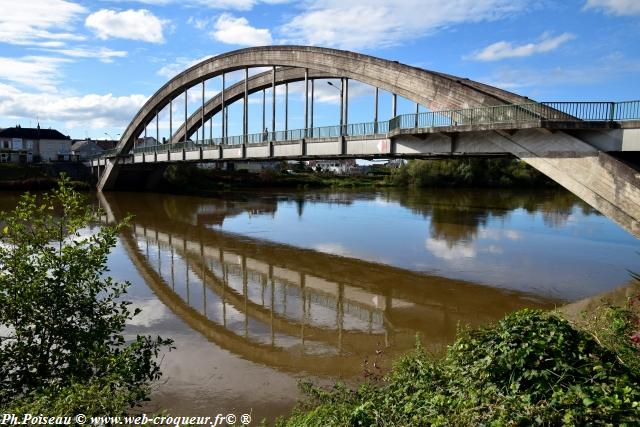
[91,46,640,236]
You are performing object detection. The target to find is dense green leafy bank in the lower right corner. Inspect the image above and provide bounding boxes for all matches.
[277,283,640,427]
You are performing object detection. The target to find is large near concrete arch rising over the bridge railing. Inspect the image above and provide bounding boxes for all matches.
[116,46,531,153]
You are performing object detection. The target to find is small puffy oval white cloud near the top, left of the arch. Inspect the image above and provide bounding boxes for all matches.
[85,9,166,43]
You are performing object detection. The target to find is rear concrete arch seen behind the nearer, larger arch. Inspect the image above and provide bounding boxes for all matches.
[170,67,332,143]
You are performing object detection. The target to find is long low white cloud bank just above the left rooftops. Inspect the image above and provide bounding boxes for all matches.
[0,84,147,129]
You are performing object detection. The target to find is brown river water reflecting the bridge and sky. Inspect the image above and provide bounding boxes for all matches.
[0,189,640,420]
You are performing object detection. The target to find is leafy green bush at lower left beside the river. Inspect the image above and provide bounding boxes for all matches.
[0,177,171,412]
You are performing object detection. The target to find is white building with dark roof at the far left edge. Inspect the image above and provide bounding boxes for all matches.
[0,125,71,163]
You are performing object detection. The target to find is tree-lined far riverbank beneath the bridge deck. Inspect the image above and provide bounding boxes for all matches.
[160,158,557,194]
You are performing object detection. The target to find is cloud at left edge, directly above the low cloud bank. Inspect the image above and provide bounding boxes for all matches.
[0,56,69,91]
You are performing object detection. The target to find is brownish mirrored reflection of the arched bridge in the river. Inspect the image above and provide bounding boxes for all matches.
[100,194,552,375]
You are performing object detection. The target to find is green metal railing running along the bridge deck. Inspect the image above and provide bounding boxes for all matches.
[93,101,640,158]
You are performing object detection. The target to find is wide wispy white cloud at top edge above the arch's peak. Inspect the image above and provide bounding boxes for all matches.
[281,0,528,49]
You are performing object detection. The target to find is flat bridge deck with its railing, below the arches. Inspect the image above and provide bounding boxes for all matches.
[92,101,640,166]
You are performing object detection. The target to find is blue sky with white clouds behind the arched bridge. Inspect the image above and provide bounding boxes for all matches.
[0,0,640,139]
